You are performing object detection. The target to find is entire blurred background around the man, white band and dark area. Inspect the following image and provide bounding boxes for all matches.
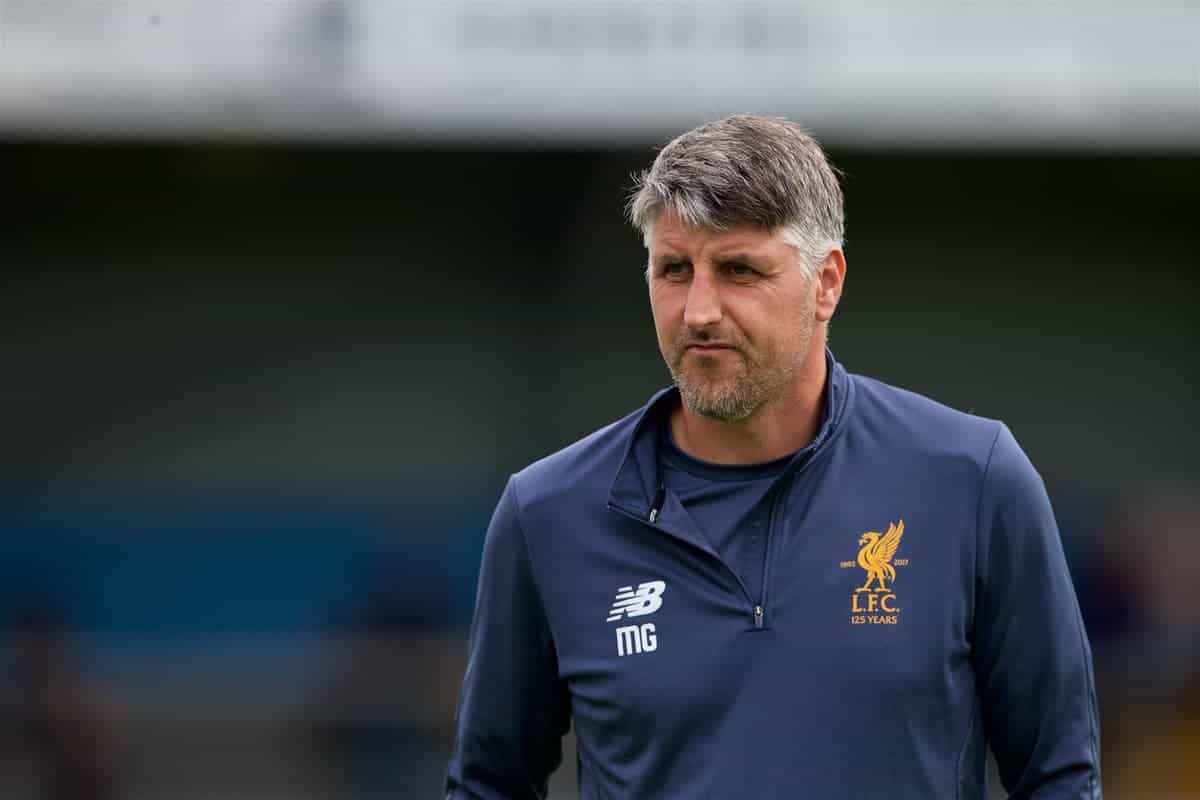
[0,0,1200,800]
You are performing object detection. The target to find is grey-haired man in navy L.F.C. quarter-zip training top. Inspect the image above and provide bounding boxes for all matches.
[446,116,1100,800]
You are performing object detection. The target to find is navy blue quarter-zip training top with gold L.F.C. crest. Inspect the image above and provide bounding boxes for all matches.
[446,352,1100,800]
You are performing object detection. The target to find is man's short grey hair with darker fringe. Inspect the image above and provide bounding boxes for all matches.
[626,114,845,273]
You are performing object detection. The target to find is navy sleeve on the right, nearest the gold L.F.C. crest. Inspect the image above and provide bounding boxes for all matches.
[972,426,1100,800]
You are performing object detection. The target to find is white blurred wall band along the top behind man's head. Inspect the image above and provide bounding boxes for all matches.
[0,0,1200,151]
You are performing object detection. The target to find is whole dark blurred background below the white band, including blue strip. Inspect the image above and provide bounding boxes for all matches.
[0,144,1200,798]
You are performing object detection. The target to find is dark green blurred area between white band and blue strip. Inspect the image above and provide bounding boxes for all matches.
[0,146,1200,488]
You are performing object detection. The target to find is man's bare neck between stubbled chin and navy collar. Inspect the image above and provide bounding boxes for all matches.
[671,342,829,464]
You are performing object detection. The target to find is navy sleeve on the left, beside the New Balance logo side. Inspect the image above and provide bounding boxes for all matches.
[446,479,570,800]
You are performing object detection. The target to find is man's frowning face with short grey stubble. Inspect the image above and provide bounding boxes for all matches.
[649,211,818,422]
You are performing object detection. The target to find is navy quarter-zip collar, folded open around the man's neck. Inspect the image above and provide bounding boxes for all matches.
[608,348,853,537]
